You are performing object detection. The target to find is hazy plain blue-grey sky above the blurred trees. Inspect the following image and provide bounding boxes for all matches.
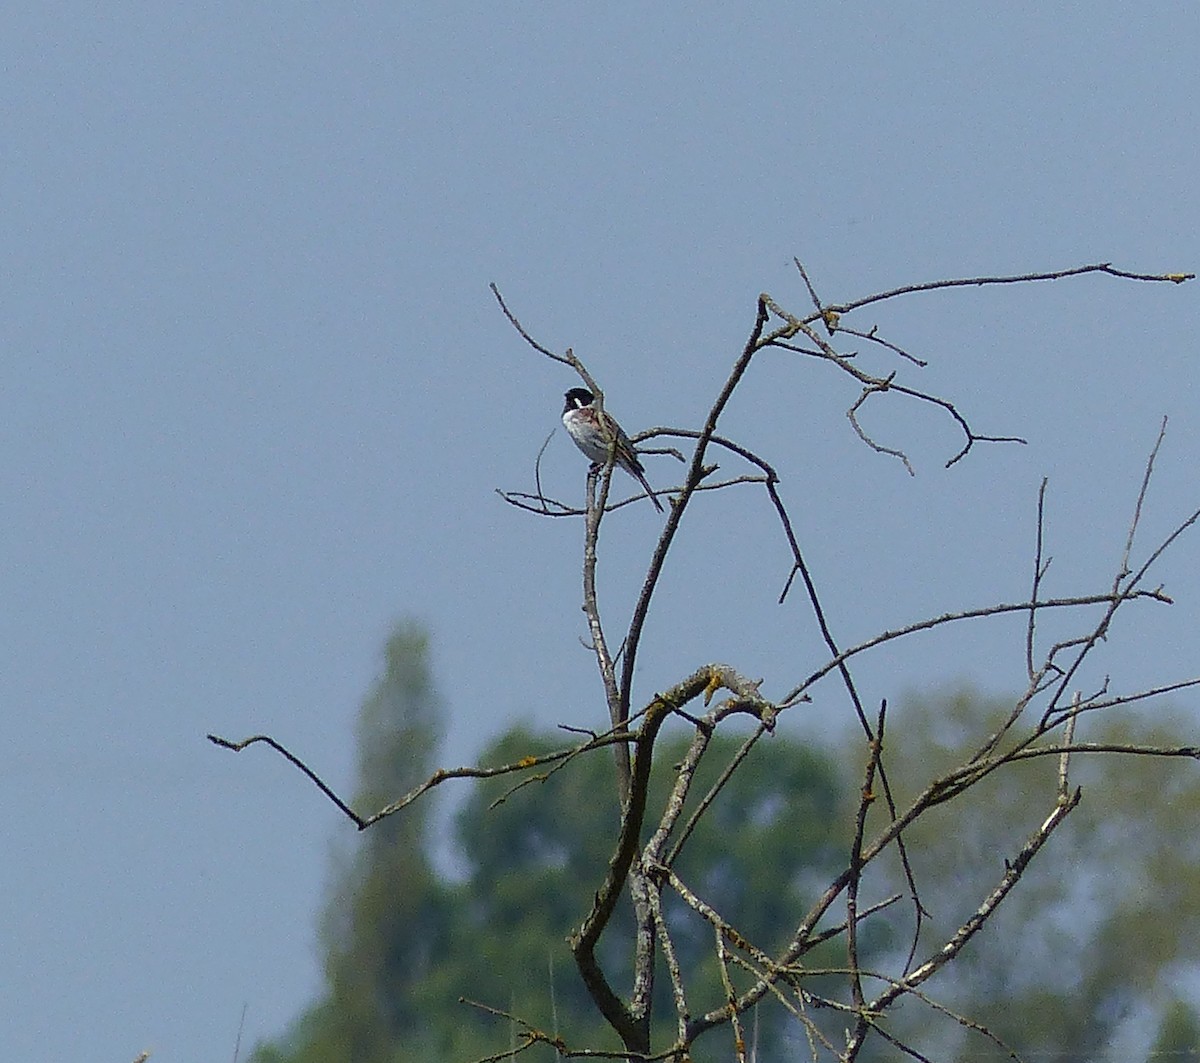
[0,2,1200,1063]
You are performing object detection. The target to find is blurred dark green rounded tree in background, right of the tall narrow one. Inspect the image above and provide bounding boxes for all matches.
[443,729,847,1061]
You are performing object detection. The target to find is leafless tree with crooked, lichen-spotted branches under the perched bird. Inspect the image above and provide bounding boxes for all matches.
[497,260,1200,1061]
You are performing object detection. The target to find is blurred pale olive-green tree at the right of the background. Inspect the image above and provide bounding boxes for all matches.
[868,692,1200,1063]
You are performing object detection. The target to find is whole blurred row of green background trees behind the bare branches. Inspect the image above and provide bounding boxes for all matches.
[254,625,1200,1063]
